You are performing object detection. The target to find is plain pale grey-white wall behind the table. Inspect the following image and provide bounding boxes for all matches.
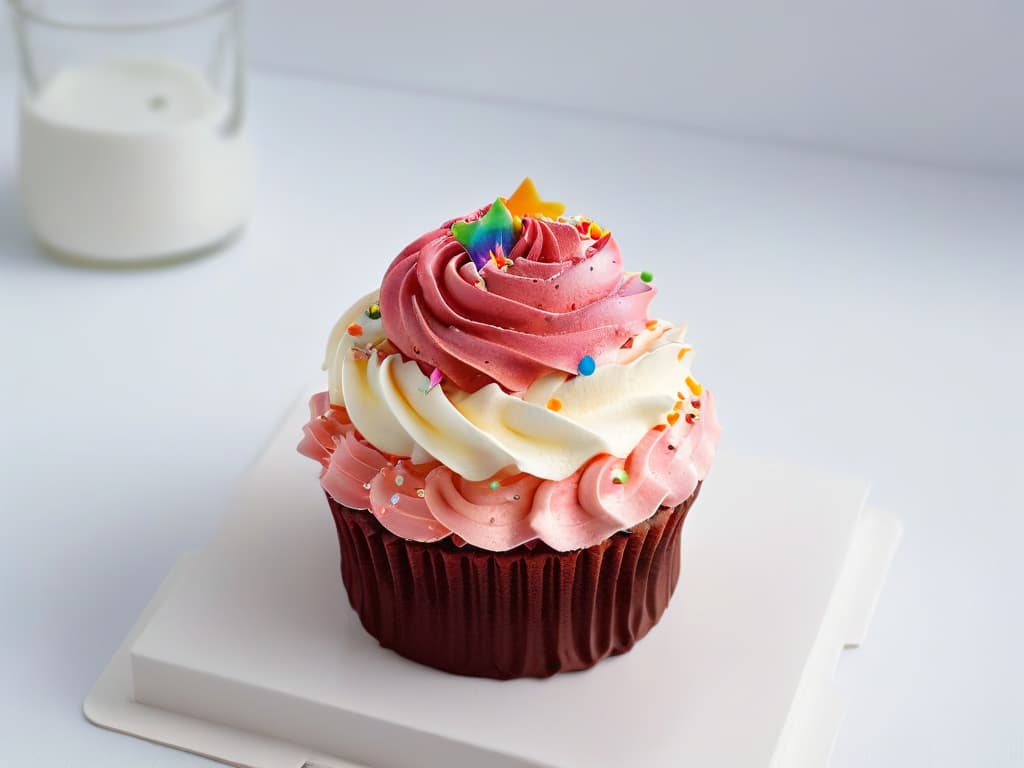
[6,0,1024,173]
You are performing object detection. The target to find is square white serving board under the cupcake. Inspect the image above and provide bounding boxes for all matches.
[85,402,900,768]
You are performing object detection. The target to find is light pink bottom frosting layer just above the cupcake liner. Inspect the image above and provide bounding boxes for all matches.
[299,391,721,552]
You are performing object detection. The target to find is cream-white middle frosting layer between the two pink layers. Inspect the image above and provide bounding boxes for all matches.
[325,293,693,480]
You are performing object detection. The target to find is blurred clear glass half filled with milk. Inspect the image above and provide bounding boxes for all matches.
[10,0,250,265]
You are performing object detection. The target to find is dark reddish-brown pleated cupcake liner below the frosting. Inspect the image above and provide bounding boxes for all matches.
[328,485,700,680]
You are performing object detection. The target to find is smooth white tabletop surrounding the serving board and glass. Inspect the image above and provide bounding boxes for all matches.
[0,70,1024,768]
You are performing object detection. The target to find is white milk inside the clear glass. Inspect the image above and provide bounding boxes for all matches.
[19,58,250,263]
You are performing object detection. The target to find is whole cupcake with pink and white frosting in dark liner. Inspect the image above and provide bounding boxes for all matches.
[299,179,720,679]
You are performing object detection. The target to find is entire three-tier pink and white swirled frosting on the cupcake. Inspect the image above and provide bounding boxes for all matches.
[299,187,720,551]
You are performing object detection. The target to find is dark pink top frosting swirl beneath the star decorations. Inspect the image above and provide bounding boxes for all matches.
[380,208,654,392]
